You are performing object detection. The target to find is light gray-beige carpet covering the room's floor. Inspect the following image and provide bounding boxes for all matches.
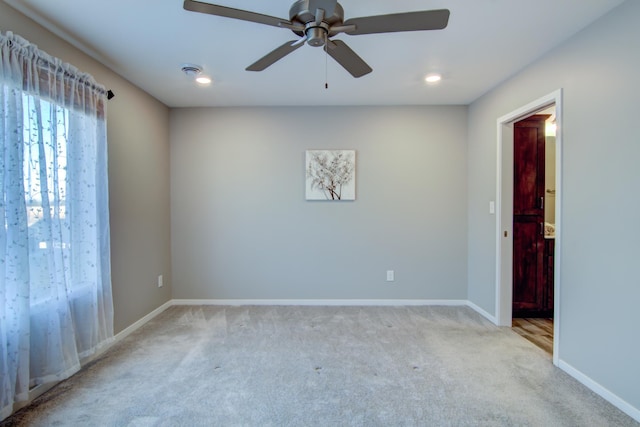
[1,306,639,427]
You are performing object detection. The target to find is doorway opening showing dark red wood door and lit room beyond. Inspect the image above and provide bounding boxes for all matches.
[512,112,555,320]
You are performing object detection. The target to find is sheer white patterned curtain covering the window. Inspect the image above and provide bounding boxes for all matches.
[0,32,113,419]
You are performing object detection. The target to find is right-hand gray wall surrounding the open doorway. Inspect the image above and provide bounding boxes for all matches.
[468,0,640,411]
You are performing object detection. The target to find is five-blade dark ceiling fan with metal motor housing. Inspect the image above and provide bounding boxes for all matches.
[184,0,449,77]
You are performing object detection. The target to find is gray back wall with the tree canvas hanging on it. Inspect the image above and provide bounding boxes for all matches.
[170,107,467,300]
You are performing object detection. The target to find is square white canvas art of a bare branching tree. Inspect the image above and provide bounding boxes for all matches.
[305,150,356,200]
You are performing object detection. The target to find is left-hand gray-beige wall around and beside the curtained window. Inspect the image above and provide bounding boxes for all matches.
[0,2,171,332]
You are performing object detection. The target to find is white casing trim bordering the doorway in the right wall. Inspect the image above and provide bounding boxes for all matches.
[495,89,563,366]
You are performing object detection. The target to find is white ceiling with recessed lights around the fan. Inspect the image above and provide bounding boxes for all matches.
[4,0,624,107]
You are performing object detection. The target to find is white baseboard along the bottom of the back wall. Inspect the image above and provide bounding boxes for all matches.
[172,299,468,307]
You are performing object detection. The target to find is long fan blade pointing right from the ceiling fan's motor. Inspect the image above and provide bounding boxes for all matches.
[344,9,450,36]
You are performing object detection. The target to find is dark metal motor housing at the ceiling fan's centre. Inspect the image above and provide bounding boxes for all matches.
[289,0,344,47]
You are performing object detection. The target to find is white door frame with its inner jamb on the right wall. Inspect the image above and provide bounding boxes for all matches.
[496,89,562,366]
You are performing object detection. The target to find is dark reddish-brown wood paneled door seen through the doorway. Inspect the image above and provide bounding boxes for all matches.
[513,115,553,317]
